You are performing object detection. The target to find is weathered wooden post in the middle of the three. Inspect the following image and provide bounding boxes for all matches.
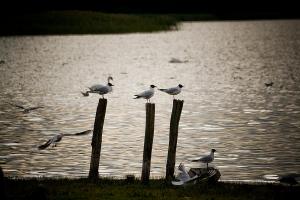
[141,103,155,184]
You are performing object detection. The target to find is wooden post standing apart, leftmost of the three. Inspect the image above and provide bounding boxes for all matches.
[89,98,107,180]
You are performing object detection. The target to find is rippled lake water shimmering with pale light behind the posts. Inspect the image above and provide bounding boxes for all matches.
[0,20,300,180]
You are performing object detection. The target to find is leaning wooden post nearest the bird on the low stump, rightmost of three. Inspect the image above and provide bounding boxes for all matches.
[166,99,184,180]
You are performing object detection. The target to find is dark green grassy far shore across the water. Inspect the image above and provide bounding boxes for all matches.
[0,10,298,36]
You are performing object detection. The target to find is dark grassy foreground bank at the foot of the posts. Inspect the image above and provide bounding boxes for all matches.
[5,179,300,200]
